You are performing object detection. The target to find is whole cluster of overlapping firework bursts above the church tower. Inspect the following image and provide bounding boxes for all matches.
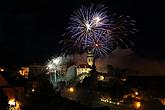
[63,5,137,57]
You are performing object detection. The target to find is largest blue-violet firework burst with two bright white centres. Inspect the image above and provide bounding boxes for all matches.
[68,5,109,42]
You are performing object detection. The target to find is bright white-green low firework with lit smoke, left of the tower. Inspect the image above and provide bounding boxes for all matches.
[46,55,76,89]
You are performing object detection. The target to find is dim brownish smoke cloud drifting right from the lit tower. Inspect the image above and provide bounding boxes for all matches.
[96,49,165,75]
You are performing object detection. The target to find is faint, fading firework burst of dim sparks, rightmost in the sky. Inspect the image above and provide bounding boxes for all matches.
[106,14,138,48]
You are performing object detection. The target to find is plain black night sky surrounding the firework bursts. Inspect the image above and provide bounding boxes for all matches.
[0,0,165,65]
